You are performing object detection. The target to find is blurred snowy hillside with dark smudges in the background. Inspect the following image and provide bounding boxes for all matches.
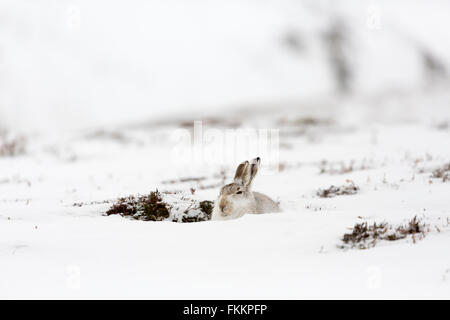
[0,0,450,133]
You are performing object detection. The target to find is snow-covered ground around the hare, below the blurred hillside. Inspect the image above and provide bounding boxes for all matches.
[0,87,450,299]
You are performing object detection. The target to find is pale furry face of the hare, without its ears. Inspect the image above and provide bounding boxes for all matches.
[217,183,253,216]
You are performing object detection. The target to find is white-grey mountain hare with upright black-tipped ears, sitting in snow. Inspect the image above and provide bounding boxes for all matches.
[211,157,280,220]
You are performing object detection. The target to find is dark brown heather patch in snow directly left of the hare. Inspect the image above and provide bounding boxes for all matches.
[106,190,214,222]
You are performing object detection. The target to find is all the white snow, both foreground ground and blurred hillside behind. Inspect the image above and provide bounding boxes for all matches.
[0,0,450,299]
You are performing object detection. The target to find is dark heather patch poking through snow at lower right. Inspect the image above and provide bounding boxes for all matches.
[340,216,429,249]
